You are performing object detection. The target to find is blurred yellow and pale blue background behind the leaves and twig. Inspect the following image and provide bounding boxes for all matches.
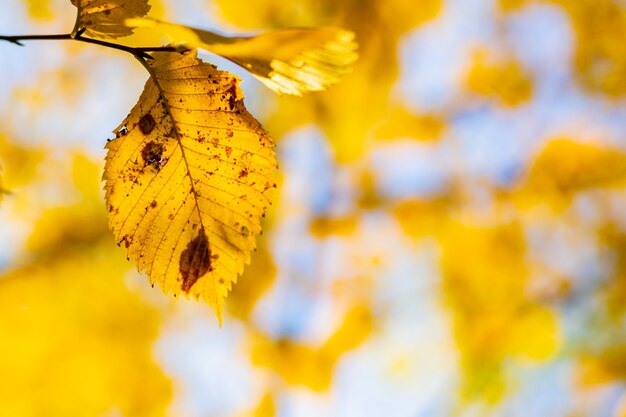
[0,0,626,417]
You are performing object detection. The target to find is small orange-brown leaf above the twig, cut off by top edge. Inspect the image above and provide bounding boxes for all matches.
[71,0,150,39]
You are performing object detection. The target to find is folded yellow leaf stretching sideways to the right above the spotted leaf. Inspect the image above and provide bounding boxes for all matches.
[127,18,358,96]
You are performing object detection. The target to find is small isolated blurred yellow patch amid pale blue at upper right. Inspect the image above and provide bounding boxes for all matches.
[466,49,533,107]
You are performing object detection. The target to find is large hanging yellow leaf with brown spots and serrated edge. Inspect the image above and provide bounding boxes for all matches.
[104,52,277,321]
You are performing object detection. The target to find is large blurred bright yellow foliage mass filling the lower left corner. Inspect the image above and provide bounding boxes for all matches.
[0,203,171,417]
